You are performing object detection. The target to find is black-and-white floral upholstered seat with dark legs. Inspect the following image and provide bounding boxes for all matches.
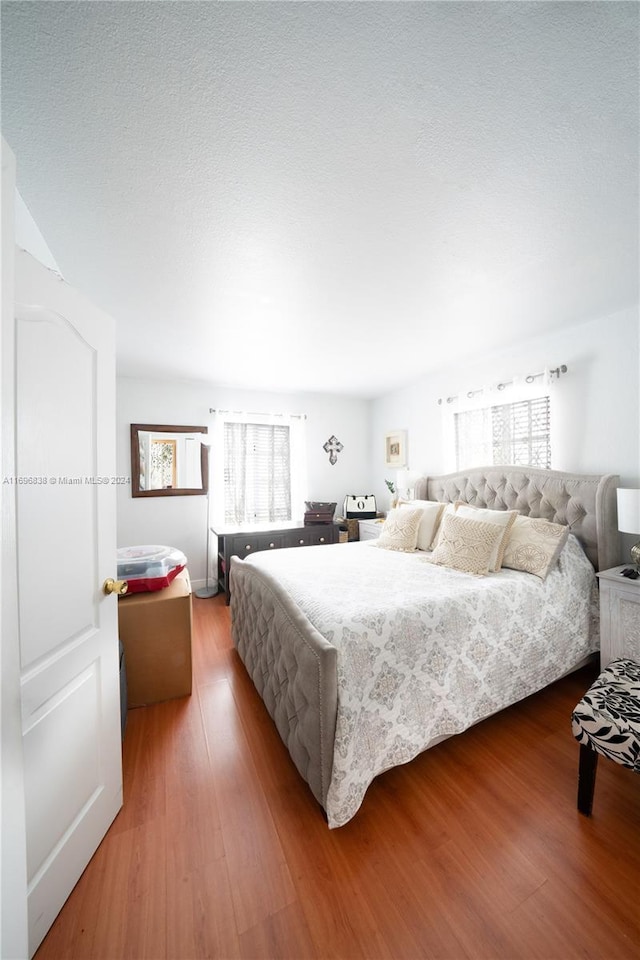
[571,660,640,817]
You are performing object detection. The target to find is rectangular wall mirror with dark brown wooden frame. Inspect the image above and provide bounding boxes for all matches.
[131,423,209,497]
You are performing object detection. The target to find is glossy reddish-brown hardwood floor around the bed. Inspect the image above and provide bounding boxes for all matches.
[36,597,640,960]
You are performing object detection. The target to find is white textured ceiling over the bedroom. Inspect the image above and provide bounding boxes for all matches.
[2,0,640,396]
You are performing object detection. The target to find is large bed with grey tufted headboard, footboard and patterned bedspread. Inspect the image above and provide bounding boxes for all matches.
[231,467,619,828]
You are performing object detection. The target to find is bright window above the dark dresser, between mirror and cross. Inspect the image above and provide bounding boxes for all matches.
[212,413,306,525]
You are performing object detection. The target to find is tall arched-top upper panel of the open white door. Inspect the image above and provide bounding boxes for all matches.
[16,307,99,670]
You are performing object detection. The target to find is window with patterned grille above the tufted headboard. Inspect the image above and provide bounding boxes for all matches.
[454,396,551,470]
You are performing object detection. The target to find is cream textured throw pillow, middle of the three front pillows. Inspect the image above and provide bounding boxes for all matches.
[429,512,503,576]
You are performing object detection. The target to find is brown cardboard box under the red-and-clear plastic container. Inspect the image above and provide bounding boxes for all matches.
[118,570,191,707]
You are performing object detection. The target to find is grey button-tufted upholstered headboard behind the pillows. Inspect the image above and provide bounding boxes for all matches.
[415,467,620,570]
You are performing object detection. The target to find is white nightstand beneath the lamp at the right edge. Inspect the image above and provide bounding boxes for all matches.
[597,564,640,669]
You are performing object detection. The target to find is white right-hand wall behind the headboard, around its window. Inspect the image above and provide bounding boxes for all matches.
[371,309,640,510]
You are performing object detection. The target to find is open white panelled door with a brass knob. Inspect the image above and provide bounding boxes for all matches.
[14,251,122,954]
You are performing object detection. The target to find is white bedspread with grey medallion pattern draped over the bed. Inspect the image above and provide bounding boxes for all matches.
[242,537,599,827]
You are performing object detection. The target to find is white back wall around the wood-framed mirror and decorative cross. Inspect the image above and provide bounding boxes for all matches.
[117,377,371,588]
